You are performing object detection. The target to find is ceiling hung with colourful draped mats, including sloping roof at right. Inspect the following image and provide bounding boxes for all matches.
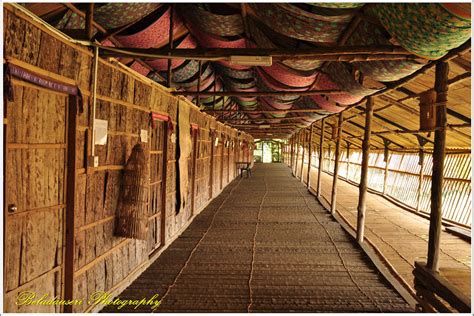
[23,3,471,149]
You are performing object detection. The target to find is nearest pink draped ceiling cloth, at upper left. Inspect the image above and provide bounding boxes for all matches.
[116,9,183,48]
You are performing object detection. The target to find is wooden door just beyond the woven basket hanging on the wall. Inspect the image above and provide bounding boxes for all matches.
[148,120,166,254]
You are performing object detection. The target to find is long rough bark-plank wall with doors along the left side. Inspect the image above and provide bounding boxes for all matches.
[4,5,253,312]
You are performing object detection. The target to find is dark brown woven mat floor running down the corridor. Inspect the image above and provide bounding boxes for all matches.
[103,164,411,312]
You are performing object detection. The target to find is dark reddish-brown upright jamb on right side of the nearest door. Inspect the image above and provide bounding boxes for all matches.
[64,95,78,313]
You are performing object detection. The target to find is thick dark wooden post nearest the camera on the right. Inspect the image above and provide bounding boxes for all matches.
[427,62,449,271]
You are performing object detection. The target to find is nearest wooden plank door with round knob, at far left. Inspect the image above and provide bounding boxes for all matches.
[3,80,68,313]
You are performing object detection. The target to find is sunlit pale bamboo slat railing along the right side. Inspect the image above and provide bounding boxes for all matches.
[312,149,472,228]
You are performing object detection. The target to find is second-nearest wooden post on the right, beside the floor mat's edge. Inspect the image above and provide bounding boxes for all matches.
[357,97,374,243]
